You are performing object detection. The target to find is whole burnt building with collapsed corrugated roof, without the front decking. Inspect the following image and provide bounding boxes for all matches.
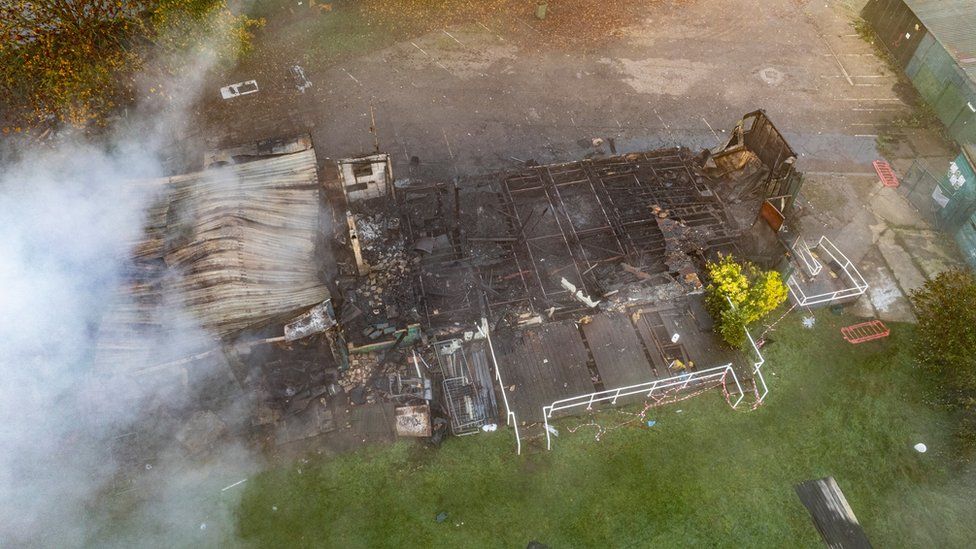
[93,111,800,466]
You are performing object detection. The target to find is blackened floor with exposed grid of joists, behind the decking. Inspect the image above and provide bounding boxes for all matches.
[395,148,740,327]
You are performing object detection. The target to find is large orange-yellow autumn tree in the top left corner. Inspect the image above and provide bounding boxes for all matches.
[0,0,258,130]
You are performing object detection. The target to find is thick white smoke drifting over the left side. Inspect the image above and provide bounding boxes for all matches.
[0,23,255,547]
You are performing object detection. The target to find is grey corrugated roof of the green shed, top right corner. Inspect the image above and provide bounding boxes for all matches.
[904,0,976,79]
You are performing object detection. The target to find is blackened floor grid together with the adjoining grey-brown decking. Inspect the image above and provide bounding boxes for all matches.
[346,148,756,422]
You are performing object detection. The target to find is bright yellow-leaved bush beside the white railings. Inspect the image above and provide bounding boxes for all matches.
[705,255,787,347]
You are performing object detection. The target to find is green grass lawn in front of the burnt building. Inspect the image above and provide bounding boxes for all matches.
[237,313,976,548]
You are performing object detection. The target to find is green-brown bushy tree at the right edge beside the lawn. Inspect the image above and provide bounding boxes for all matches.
[912,269,976,450]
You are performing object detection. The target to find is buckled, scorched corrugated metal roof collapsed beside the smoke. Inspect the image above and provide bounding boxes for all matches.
[95,149,329,371]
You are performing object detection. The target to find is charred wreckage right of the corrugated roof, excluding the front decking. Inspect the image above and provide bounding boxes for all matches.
[326,111,801,440]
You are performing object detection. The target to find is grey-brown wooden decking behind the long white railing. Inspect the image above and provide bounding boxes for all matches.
[496,295,750,422]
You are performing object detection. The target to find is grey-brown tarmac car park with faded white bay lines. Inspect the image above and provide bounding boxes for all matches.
[194,0,960,320]
